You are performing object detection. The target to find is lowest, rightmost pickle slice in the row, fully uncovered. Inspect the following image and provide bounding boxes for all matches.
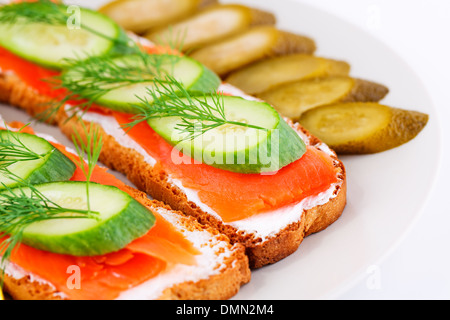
[299,102,428,154]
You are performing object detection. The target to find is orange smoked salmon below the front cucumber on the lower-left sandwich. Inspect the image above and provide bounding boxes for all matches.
[10,244,166,300]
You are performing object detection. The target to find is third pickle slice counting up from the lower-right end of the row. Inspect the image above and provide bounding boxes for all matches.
[225,54,350,95]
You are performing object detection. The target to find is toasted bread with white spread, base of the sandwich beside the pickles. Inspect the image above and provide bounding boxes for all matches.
[0,75,346,268]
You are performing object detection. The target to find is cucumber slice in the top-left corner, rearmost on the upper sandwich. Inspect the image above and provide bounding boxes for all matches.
[0,3,122,69]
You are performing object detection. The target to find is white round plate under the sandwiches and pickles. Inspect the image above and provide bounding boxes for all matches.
[0,0,441,300]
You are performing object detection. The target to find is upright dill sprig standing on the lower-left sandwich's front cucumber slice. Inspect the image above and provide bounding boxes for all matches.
[72,122,103,211]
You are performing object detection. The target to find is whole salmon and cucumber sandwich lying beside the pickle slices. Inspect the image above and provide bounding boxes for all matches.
[0,1,346,268]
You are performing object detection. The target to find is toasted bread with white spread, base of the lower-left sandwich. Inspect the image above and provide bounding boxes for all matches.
[0,117,251,300]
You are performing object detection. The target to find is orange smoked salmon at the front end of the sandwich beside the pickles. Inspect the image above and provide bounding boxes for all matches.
[113,112,338,222]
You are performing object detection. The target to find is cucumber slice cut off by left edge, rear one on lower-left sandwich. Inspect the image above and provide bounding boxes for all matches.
[0,130,76,189]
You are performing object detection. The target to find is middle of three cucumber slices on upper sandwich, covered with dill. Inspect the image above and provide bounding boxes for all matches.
[62,54,221,113]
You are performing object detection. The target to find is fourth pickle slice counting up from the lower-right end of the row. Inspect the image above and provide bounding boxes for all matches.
[191,26,316,77]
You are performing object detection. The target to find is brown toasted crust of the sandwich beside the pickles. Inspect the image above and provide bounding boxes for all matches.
[0,71,347,269]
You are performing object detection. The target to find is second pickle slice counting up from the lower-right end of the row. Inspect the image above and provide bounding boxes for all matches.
[258,76,388,120]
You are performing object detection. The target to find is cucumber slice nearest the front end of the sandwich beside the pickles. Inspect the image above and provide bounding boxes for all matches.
[148,96,306,174]
